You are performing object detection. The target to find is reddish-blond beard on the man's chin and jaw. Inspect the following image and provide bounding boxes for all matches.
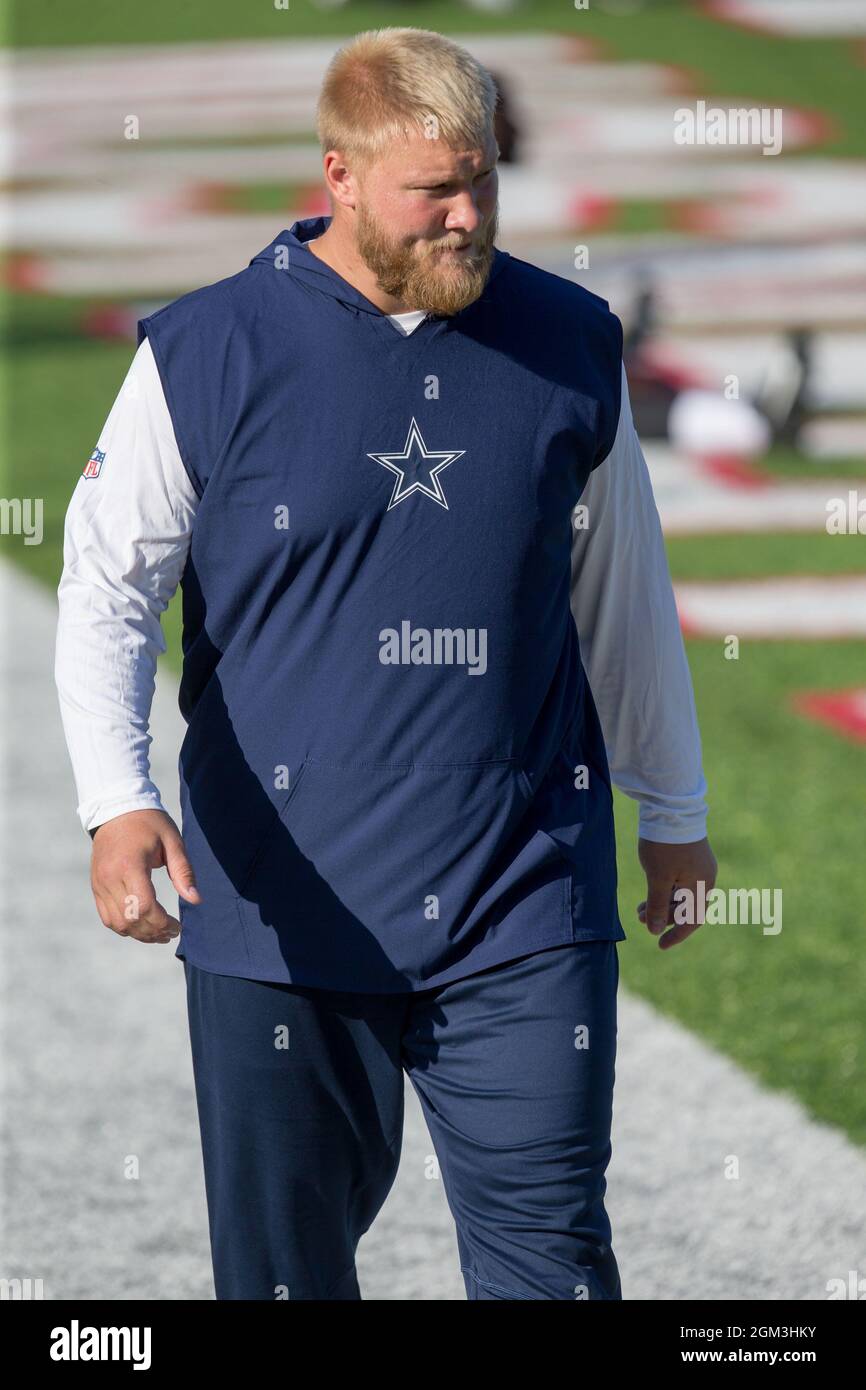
[356,203,499,317]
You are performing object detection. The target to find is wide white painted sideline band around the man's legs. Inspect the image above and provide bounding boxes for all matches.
[0,562,866,1302]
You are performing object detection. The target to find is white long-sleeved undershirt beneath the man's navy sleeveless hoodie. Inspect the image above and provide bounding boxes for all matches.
[54,325,706,844]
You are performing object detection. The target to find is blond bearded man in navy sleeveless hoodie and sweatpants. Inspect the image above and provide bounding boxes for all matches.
[57,29,716,1300]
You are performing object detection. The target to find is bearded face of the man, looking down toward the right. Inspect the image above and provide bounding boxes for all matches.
[354,135,499,316]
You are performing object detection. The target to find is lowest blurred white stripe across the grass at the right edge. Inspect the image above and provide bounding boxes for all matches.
[674,574,866,639]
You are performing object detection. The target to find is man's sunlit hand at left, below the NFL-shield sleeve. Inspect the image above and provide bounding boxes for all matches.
[90,810,202,945]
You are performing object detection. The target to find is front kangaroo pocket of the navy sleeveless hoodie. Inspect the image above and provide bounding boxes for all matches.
[233,759,570,937]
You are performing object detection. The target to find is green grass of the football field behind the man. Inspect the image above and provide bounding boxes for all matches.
[0,0,866,1144]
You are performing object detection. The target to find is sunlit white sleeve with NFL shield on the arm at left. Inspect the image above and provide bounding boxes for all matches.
[54,338,197,830]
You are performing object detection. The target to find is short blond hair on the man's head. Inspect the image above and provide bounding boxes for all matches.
[317,28,496,167]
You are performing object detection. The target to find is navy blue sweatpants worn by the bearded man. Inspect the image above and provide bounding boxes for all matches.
[183,941,621,1300]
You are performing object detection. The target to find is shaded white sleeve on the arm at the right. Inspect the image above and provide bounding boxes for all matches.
[571,366,708,844]
